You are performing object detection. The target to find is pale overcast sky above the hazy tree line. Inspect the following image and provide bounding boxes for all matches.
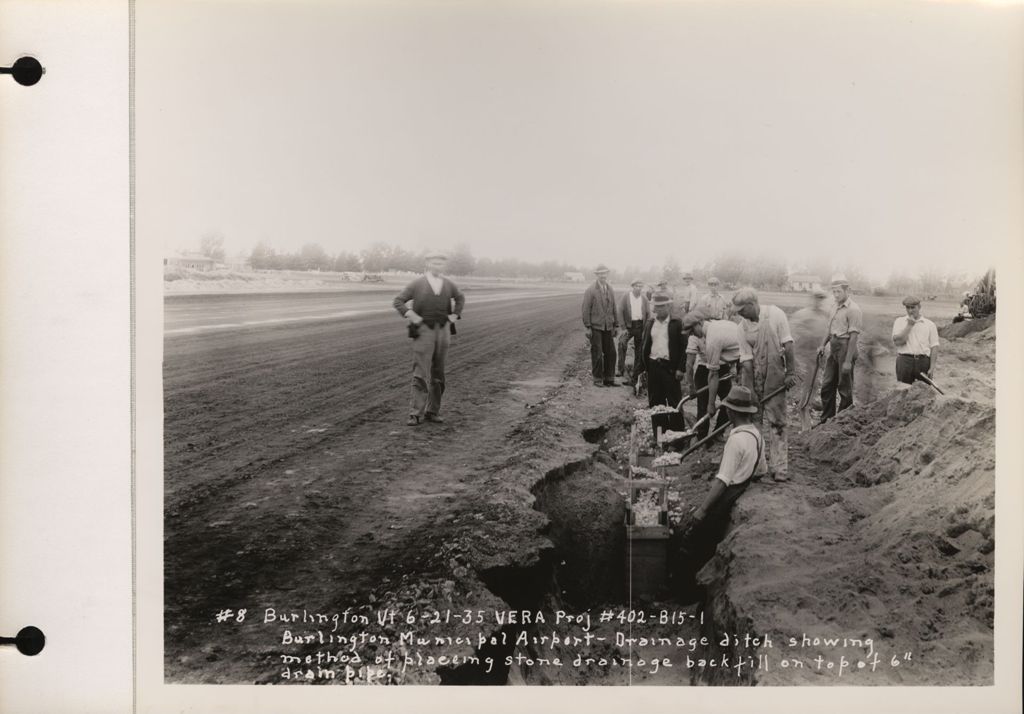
[136,0,1024,280]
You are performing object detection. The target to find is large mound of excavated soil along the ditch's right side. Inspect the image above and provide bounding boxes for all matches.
[700,383,995,684]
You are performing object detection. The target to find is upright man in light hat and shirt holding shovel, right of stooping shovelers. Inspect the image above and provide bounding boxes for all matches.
[818,274,864,417]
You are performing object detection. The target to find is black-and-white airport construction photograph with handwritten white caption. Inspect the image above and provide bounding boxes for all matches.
[133,0,1022,687]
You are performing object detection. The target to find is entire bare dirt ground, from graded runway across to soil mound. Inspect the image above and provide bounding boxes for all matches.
[165,294,994,684]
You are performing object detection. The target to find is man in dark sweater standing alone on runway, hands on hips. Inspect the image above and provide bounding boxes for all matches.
[393,251,466,426]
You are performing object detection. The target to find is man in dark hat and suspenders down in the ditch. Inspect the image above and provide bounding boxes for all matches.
[674,385,768,602]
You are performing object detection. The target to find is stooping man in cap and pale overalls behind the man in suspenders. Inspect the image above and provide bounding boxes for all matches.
[732,288,797,481]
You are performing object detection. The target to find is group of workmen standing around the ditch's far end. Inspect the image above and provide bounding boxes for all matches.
[583,265,938,481]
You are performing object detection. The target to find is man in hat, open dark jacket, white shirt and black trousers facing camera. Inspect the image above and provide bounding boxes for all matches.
[640,293,686,407]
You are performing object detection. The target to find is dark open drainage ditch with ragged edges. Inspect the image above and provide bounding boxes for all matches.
[438,418,753,685]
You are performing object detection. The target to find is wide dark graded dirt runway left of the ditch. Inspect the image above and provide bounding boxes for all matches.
[164,284,602,681]
